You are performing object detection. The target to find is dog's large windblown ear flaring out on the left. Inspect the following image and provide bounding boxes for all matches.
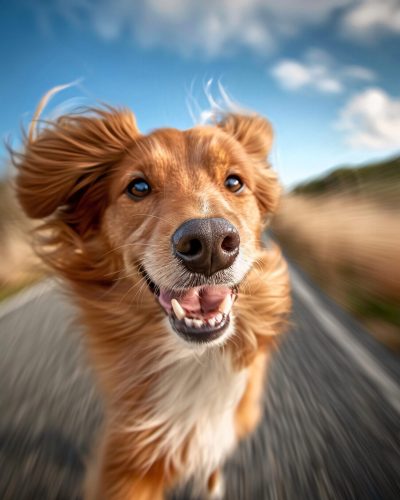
[11,108,140,282]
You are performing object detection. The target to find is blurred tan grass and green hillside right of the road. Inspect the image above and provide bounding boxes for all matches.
[274,156,400,351]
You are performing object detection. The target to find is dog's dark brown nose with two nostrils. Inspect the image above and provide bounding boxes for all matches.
[172,218,240,276]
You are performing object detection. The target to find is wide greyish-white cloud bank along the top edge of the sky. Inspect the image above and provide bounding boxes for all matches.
[37,0,353,57]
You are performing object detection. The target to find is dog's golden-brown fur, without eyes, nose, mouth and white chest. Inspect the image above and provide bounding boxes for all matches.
[13,94,290,500]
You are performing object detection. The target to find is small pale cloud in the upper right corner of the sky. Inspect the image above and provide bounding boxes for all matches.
[343,0,400,39]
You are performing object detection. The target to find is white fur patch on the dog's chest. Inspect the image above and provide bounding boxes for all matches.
[150,353,247,479]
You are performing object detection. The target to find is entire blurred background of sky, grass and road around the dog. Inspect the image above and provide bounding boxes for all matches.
[0,0,400,500]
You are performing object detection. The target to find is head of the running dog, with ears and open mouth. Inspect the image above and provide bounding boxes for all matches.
[16,109,279,344]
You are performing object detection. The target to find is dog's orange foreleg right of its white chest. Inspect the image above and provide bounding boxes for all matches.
[235,351,268,439]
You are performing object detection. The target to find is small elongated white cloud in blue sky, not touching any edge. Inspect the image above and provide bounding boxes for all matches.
[271,49,375,94]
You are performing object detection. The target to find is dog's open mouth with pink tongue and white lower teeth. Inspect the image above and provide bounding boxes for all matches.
[142,271,237,343]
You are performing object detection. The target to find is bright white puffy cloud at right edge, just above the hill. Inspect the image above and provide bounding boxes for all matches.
[336,88,400,150]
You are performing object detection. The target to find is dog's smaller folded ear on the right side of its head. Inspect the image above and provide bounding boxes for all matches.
[218,113,281,216]
